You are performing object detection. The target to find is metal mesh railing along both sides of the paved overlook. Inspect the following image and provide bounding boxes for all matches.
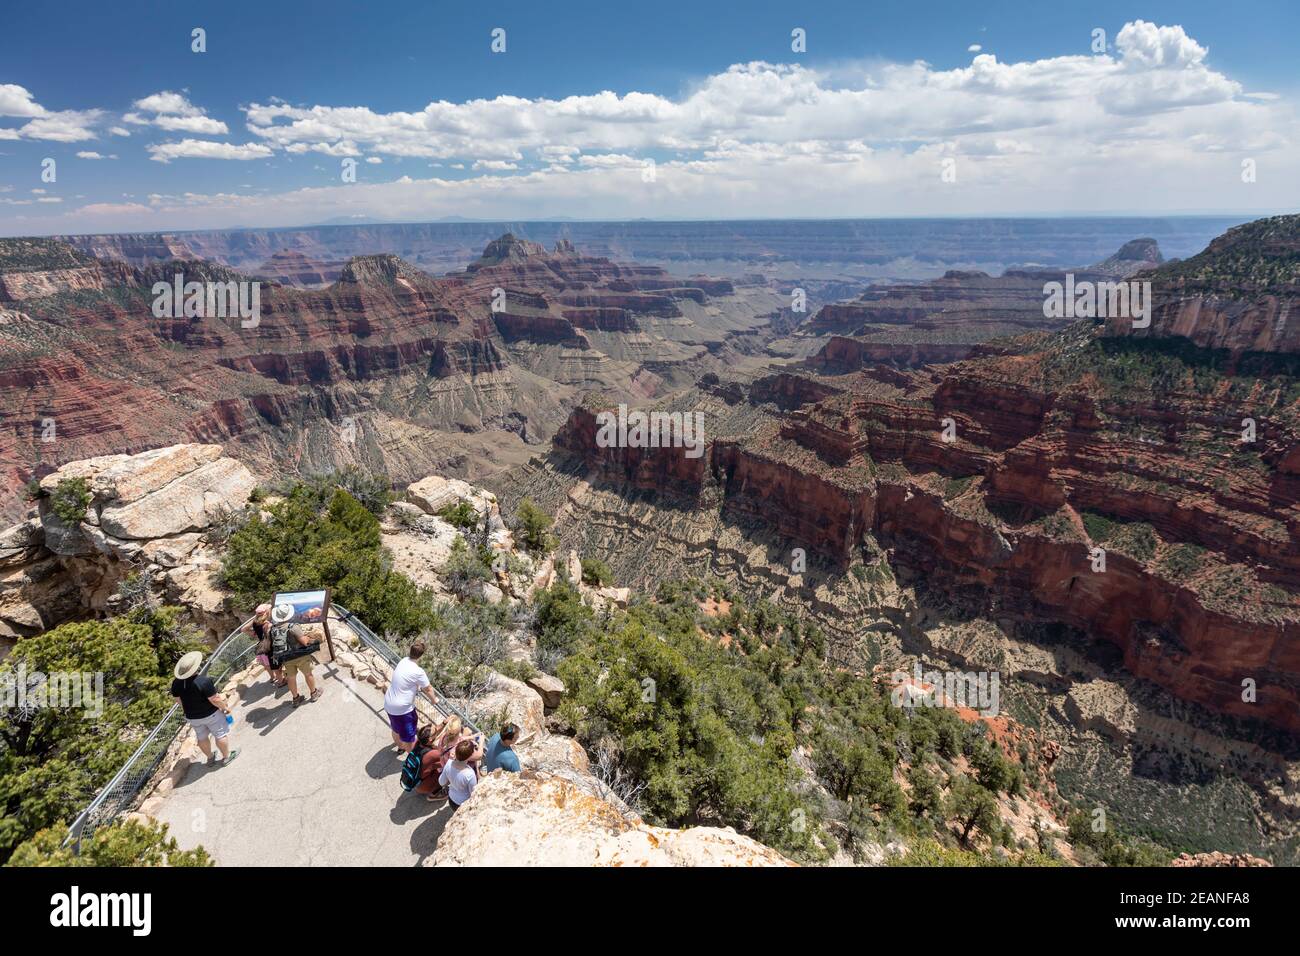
[62,605,478,852]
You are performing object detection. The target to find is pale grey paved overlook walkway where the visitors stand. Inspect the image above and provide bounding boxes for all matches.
[156,663,450,866]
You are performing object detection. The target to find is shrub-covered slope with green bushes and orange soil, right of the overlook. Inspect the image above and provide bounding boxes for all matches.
[533,572,1149,865]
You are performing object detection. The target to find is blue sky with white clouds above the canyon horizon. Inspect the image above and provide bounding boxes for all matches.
[0,0,1300,234]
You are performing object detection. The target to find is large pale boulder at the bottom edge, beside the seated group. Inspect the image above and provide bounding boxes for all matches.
[424,771,792,866]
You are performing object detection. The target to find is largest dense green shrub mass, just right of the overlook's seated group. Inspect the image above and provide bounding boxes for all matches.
[534,580,827,860]
